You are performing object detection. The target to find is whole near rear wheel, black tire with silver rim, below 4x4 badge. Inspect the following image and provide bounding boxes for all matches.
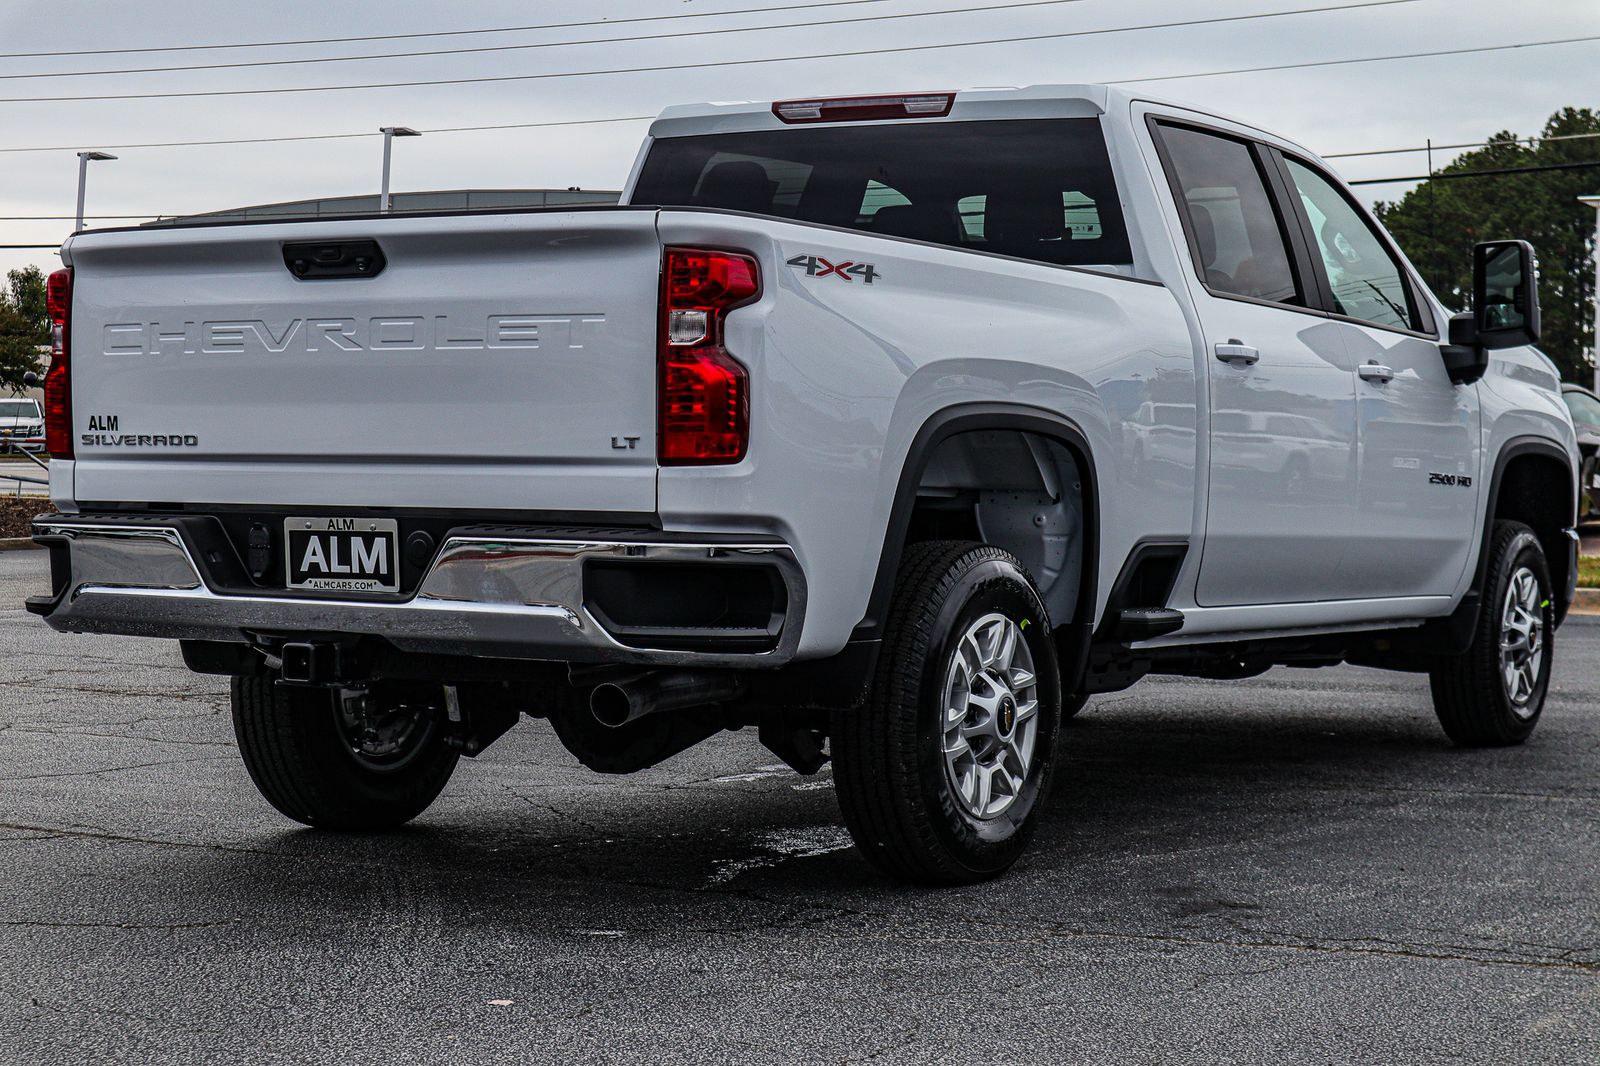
[830,541,1061,885]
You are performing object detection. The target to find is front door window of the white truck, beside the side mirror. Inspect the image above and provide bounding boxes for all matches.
[1283,155,1416,330]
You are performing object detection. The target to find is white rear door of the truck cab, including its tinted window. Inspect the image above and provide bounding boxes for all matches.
[1155,122,1357,607]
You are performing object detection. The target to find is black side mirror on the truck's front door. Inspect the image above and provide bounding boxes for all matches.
[1443,240,1539,384]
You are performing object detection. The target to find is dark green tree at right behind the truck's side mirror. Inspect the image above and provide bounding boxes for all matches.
[1376,107,1600,384]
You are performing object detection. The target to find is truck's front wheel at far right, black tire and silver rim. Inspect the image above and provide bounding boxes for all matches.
[1429,520,1555,747]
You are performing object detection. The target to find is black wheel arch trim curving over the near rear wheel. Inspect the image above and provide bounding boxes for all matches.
[853,402,1101,691]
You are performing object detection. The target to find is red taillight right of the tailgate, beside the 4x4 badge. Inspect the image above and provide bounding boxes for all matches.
[656,248,762,466]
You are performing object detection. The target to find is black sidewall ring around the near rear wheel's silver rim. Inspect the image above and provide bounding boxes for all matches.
[915,559,1061,872]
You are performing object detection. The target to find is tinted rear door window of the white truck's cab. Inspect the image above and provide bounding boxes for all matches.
[1162,125,1306,307]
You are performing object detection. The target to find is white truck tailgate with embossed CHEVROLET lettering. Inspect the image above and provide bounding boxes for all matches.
[66,208,661,512]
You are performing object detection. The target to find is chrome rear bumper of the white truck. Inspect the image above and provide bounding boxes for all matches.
[27,515,806,667]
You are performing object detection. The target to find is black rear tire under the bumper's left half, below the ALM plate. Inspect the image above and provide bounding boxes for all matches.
[232,677,458,831]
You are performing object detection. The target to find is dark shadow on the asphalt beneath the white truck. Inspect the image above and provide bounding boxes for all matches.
[152,694,1539,932]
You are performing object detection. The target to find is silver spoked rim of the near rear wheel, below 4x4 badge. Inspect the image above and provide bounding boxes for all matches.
[941,613,1038,821]
